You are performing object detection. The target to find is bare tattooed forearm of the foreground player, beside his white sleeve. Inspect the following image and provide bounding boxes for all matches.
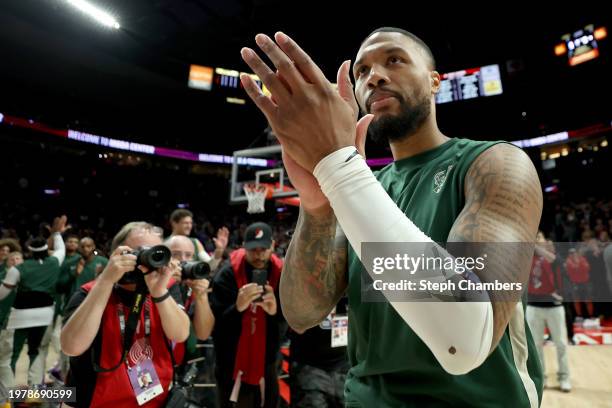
[280,208,347,332]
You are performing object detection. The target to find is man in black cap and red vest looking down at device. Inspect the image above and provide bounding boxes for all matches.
[211,223,284,408]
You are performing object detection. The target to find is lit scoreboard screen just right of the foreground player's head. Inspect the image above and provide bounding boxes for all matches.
[436,64,503,104]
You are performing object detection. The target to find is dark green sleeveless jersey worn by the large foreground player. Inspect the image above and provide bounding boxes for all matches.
[345,139,543,408]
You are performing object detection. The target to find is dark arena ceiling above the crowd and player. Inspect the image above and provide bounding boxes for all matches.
[0,0,611,153]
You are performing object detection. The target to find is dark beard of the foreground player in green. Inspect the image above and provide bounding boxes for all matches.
[368,91,431,143]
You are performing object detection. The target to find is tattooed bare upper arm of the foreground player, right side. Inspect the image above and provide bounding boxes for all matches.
[448,144,542,350]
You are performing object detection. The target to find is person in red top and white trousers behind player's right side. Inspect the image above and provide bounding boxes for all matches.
[526,231,572,392]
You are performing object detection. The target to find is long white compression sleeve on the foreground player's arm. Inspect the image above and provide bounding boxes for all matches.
[313,147,493,375]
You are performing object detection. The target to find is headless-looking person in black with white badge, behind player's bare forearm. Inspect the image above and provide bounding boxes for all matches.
[289,298,350,408]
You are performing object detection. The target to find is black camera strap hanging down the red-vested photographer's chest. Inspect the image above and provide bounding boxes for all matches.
[91,292,151,373]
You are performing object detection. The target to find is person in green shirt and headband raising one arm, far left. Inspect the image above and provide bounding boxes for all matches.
[0,216,66,385]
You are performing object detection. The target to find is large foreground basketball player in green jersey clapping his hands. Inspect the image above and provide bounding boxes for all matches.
[241,28,542,407]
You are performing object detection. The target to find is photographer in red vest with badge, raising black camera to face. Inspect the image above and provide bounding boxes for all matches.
[61,222,189,407]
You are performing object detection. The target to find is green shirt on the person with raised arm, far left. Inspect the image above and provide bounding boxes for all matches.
[17,256,60,296]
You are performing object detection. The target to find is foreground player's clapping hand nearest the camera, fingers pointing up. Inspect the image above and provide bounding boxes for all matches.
[241,32,367,173]
